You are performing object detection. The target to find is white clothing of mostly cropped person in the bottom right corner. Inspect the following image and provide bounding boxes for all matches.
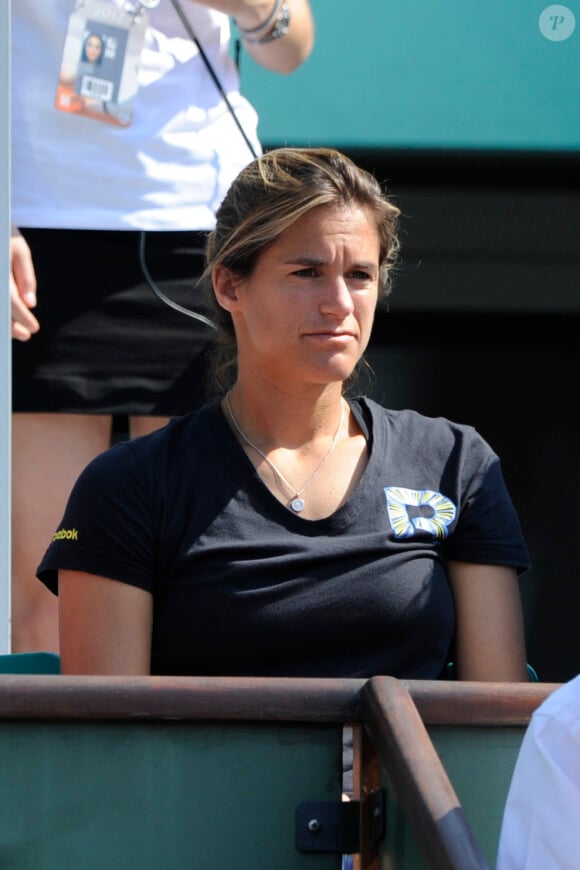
[496,675,580,870]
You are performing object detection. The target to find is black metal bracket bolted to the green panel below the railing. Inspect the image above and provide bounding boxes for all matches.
[296,789,385,855]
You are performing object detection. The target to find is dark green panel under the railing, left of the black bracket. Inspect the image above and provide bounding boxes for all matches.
[0,722,341,870]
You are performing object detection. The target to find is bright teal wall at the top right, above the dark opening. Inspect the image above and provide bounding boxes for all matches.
[236,0,580,150]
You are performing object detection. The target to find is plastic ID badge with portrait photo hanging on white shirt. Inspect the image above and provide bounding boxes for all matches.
[55,0,154,127]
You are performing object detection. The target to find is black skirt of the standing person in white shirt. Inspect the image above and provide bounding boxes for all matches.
[12,229,218,416]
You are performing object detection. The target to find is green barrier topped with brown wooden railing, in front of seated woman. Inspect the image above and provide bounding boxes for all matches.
[0,675,555,870]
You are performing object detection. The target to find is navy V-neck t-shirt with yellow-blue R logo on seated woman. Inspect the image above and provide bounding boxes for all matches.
[38,399,528,679]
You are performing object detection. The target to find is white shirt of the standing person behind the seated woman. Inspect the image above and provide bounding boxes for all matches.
[11,0,259,230]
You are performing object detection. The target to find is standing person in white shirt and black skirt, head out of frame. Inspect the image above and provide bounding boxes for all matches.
[10,0,313,652]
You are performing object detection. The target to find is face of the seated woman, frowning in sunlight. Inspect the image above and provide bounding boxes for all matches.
[218,205,380,384]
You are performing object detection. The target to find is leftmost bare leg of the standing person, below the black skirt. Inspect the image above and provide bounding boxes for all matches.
[12,414,111,652]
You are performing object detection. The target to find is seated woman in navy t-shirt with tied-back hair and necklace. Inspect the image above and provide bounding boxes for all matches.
[38,148,528,681]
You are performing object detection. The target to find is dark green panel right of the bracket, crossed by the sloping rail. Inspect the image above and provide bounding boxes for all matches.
[381,726,525,870]
